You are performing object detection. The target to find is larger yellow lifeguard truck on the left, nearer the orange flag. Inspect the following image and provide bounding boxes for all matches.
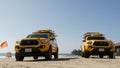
[15,30,58,61]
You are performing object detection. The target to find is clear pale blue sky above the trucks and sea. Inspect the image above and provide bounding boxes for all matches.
[0,0,120,53]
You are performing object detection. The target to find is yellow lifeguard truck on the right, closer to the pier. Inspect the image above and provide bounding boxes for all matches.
[81,32,115,58]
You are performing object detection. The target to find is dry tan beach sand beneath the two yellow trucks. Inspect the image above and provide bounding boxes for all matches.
[0,56,120,68]
